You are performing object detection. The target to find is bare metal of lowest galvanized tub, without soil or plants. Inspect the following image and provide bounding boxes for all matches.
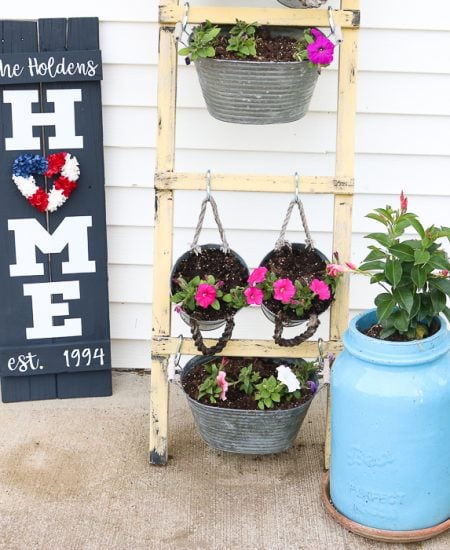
[181,357,313,455]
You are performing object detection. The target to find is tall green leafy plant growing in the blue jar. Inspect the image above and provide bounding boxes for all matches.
[357,192,450,340]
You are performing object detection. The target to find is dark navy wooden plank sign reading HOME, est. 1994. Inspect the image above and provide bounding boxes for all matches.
[0,18,111,402]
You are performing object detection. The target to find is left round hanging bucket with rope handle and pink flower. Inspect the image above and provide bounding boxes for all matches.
[170,188,249,355]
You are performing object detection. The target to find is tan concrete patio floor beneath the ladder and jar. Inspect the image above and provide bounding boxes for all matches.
[0,372,450,550]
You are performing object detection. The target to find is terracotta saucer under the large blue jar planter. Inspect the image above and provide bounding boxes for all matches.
[320,472,450,542]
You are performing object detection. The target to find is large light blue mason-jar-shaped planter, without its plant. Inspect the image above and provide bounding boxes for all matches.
[330,310,450,531]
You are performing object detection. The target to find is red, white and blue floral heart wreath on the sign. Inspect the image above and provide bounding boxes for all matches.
[12,153,80,212]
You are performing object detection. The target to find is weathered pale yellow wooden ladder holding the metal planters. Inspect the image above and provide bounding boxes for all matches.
[150,0,359,468]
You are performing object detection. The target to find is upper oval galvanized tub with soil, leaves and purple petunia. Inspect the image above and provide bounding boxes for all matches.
[180,21,334,124]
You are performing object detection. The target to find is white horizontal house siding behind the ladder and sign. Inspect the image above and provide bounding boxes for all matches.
[2,0,450,368]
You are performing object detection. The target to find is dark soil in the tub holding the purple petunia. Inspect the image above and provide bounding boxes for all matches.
[214,27,297,61]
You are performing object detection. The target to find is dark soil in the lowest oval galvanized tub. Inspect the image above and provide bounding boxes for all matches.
[183,357,312,410]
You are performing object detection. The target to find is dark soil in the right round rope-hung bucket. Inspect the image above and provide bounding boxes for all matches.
[261,245,332,320]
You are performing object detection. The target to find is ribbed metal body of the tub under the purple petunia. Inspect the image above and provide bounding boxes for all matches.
[195,58,318,124]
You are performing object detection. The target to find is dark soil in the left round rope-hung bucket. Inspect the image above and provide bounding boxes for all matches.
[172,247,249,321]
